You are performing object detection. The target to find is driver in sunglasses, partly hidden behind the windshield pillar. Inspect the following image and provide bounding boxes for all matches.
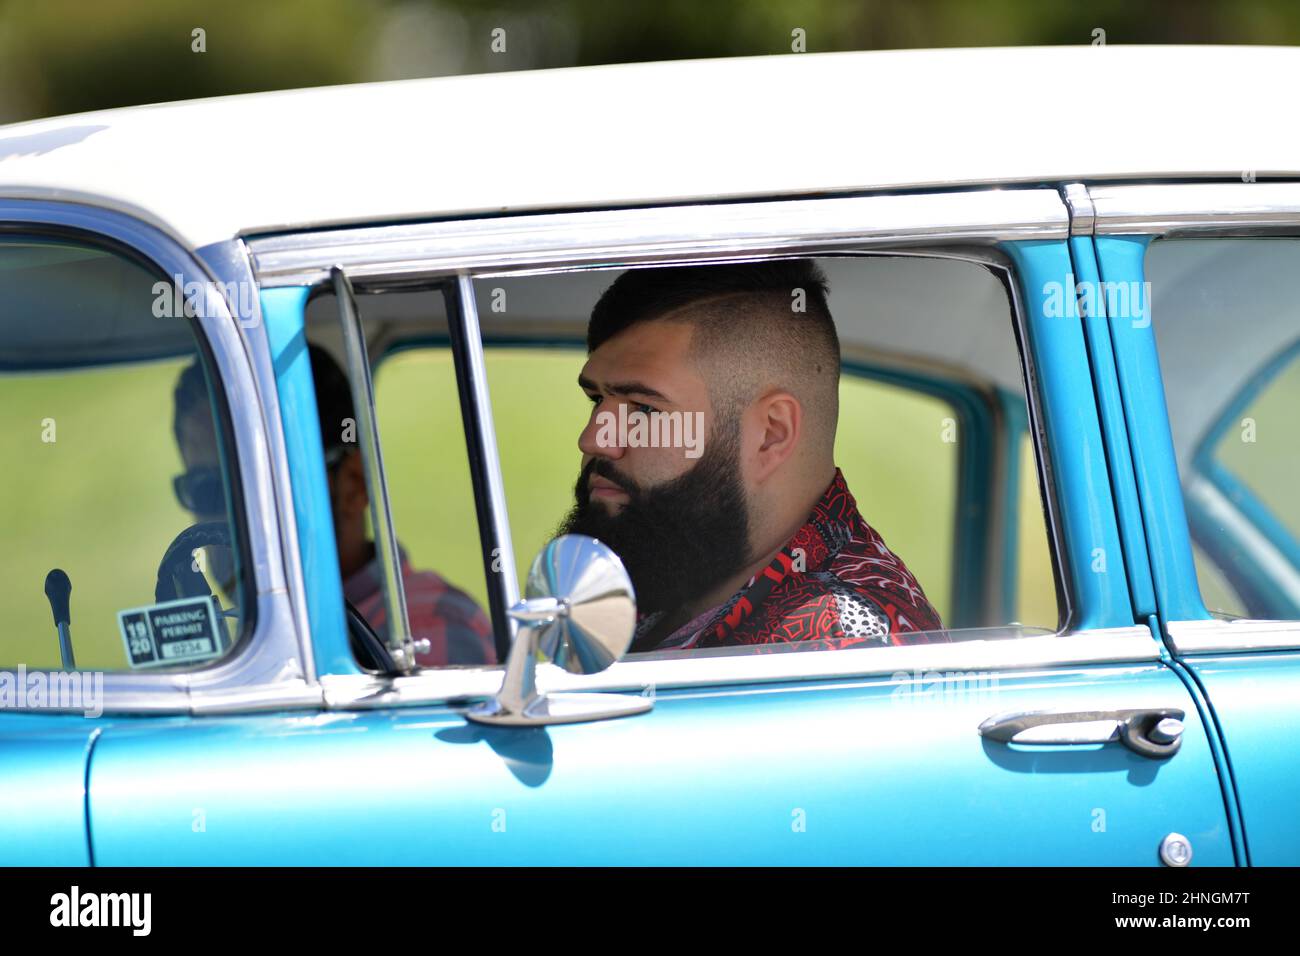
[174,345,497,667]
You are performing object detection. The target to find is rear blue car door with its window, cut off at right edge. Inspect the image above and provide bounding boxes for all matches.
[1091,181,1300,866]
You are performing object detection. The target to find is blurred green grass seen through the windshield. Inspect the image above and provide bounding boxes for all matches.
[0,360,194,670]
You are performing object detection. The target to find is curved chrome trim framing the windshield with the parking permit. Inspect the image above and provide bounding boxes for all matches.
[0,199,313,714]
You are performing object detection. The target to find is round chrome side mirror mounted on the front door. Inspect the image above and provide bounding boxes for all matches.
[465,535,653,727]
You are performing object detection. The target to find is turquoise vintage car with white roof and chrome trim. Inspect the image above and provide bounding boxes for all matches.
[0,46,1300,866]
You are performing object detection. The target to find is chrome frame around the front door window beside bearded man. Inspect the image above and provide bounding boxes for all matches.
[248,189,1160,709]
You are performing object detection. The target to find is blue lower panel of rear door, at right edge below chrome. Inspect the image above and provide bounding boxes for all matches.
[1186,652,1300,866]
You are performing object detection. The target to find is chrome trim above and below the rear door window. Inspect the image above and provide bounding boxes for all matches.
[1087,181,1300,654]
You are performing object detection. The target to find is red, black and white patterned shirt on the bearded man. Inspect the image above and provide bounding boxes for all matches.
[637,468,949,650]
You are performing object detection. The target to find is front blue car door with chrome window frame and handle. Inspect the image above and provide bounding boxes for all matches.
[78,189,1240,865]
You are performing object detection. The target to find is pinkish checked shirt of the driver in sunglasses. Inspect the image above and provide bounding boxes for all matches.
[343,550,497,667]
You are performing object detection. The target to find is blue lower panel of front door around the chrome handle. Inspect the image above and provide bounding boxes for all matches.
[91,665,1234,865]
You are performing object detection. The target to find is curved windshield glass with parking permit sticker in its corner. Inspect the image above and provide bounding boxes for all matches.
[0,237,252,672]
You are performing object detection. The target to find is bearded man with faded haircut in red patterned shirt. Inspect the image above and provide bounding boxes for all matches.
[560,261,948,652]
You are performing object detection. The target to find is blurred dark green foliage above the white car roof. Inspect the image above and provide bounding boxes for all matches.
[0,0,1300,122]
